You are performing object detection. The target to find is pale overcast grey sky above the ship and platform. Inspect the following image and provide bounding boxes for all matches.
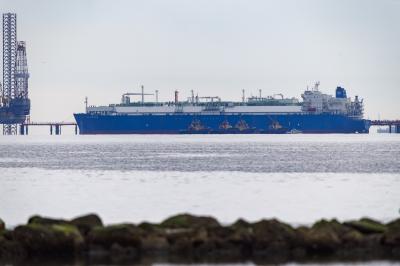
[0,0,400,121]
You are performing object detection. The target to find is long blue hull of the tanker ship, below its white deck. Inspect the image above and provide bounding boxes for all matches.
[74,113,370,134]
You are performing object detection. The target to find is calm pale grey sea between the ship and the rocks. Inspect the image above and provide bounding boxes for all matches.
[0,134,400,226]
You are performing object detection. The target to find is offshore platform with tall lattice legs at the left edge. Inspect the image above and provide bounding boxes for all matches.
[0,13,30,135]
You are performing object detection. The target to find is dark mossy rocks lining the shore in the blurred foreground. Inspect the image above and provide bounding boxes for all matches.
[0,214,400,263]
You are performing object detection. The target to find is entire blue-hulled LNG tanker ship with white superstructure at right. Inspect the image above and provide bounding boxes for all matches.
[74,83,370,134]
